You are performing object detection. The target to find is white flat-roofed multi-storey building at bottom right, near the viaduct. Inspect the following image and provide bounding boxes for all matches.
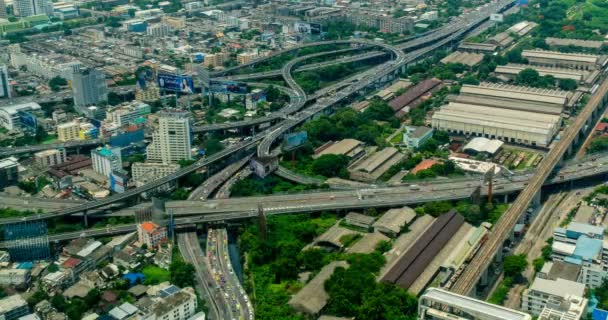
[521,278,585,316]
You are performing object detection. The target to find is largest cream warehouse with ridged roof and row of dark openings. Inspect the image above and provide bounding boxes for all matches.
[432,102,561,147]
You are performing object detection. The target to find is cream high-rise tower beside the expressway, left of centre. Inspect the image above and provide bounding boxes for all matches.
[147,110,192,164]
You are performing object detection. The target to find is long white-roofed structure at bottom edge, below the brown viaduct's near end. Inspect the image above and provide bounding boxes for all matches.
[418,288,532,320]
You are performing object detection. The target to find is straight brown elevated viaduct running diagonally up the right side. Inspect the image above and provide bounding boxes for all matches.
[451,80,608,295]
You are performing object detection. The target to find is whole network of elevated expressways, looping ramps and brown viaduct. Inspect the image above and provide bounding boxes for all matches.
[0,0,576,310]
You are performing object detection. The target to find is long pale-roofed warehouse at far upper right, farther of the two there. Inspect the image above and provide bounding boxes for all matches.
[521,50,606,70]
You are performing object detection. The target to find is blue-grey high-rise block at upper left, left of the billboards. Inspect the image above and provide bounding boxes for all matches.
[72,69,108,109]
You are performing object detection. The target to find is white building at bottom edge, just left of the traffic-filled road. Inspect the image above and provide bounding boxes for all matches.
[146,287,197,320]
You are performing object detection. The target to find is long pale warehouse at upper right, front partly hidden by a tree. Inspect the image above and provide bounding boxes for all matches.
[494,63,599,85]
